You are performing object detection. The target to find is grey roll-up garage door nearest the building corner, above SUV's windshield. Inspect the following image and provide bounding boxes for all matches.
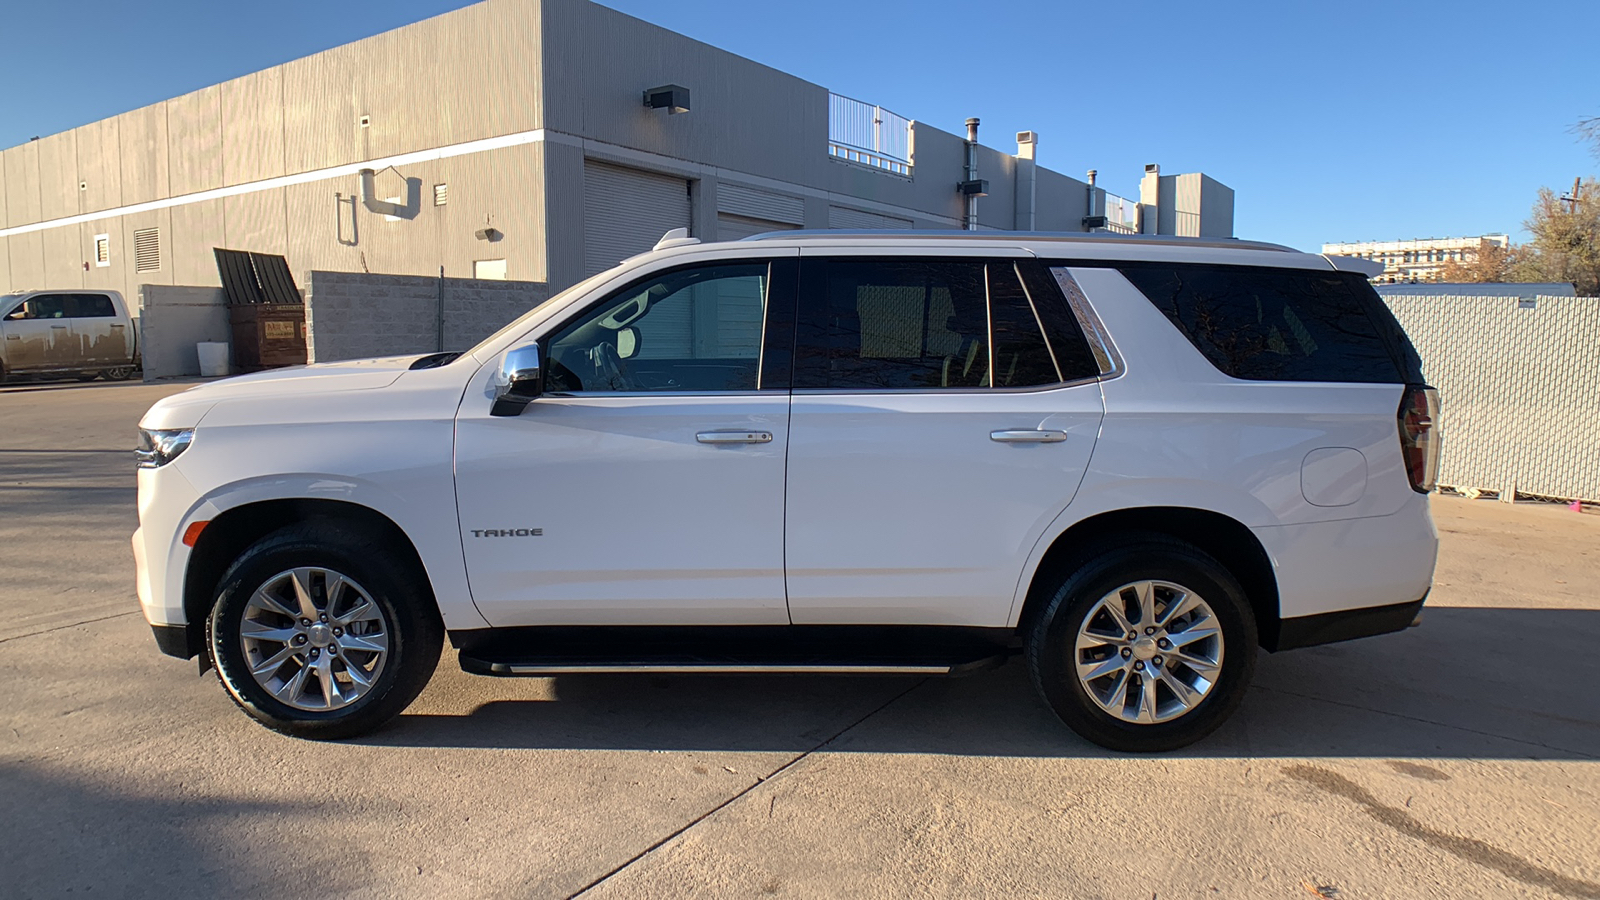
[584,160,690,275]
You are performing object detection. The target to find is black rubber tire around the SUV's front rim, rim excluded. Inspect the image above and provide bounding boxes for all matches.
[206,520,445,740]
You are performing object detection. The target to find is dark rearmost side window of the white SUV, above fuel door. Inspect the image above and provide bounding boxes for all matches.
[1122,264,1405,384]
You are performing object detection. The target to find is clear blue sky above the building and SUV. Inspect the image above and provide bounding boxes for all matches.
[0,0,1600,248]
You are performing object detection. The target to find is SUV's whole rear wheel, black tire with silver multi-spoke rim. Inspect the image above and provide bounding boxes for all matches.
[1027,535,1256,753]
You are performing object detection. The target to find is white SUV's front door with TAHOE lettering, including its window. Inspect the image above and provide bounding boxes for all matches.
[456,258,795,626]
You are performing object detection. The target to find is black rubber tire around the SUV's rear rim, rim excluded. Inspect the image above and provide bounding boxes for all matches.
[1026,535,1258,753]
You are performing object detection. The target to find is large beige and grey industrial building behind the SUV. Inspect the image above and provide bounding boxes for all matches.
[0,0,1234,299]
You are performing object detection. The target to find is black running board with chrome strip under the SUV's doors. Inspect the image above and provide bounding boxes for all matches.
[451,626,1013,677]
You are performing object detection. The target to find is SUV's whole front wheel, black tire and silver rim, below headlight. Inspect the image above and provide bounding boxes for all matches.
[206,522,443,740]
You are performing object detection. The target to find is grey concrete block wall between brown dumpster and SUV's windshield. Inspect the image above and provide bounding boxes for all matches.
[306,271,550,362]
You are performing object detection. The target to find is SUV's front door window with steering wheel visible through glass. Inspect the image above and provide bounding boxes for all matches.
[546,263,768,392]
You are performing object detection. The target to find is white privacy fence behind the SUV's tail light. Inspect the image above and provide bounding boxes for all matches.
[1384,296,1600,501]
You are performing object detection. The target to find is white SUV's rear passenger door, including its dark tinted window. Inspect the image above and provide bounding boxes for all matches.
[786,256,1104,626]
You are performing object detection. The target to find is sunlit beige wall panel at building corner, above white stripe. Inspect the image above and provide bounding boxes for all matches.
[483,0,546,135]
